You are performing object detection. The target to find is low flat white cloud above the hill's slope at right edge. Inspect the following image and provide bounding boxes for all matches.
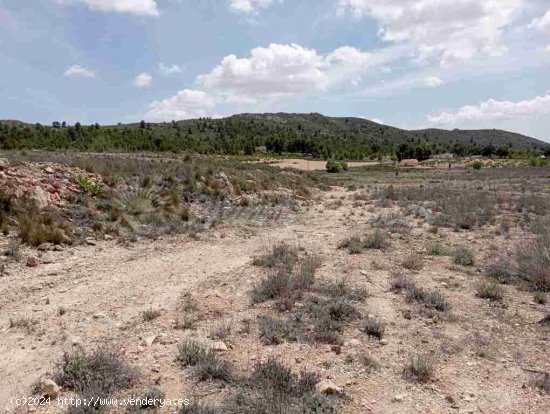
[428,93,550,127]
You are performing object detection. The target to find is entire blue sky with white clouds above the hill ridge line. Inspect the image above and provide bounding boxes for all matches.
[0,0,550,142]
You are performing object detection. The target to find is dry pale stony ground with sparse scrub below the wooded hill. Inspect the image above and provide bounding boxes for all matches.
[0,152,550,414]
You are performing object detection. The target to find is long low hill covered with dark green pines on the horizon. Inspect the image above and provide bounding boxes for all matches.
[0,113,550,159]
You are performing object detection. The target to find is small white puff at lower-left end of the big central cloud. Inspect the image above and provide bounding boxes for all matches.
[146,89,217,121]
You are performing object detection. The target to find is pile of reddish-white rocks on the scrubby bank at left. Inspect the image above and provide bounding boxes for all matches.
[0,163,103,209]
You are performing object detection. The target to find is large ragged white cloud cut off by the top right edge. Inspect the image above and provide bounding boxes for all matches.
[338,0,526,66]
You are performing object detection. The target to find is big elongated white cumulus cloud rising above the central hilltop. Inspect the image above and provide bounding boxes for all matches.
[148,44,378,119]
